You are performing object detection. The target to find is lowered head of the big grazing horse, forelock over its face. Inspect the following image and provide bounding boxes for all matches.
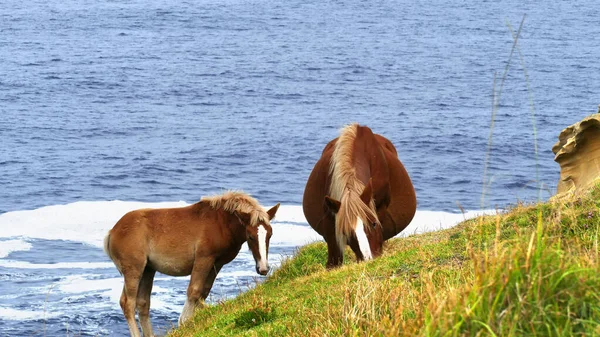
[325,180,383,260]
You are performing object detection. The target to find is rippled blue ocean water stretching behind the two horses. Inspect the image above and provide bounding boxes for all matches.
[0,0,600,336]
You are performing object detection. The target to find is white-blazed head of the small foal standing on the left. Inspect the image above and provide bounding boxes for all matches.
[241,204,279,275]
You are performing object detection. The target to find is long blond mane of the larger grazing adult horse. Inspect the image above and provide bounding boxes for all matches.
[329,123,377,244]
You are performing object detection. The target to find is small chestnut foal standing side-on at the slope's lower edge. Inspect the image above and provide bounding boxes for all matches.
[104,192,279,337]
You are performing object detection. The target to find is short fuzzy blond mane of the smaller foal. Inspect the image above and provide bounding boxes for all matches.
[200,191,269,227]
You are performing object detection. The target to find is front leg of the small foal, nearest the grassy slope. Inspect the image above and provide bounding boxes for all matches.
[179,257,215,325]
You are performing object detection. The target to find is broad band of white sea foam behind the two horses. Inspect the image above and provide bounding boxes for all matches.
[0,200,494,252]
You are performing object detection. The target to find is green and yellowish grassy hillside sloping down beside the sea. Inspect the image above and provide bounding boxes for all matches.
[169,188,600,336]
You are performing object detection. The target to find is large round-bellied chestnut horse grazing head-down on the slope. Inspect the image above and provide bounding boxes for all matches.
[302,124,417,268]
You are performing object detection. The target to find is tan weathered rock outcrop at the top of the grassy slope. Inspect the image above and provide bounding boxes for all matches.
[552,106,600,198]
